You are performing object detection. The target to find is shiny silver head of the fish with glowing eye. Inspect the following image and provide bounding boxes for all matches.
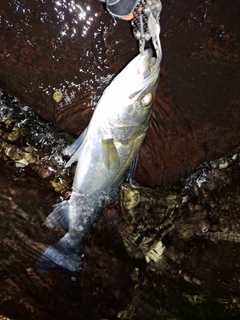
[108,49,160,139]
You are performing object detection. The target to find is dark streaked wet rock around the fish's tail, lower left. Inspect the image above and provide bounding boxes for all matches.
[0,165,132,320]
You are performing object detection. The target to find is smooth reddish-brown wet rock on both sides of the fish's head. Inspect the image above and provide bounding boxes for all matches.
[0,0,240,186]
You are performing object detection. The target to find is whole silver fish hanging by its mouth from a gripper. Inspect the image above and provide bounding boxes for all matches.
[37,49,160,272]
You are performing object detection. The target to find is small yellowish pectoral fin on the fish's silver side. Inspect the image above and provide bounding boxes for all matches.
[102,139,120,170]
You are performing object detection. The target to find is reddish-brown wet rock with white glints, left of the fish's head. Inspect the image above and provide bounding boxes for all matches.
[0,0,136,134]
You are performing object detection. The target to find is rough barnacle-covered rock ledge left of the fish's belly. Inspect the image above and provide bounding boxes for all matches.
[0,94,73,193]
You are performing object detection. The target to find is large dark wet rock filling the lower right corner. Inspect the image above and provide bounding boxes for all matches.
[118,149,240,320]
